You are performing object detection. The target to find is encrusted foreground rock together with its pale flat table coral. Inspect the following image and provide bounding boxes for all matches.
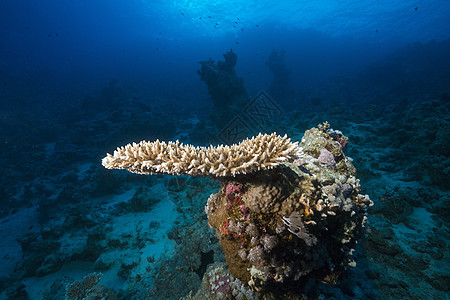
[103,123,372,299]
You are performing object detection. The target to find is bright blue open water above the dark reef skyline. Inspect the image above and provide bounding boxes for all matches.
[0,0,450,101]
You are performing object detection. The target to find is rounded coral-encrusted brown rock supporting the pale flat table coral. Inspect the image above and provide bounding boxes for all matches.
[103,123,373,297]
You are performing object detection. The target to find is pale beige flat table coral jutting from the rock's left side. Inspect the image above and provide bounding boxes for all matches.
[102,133,301,177]
